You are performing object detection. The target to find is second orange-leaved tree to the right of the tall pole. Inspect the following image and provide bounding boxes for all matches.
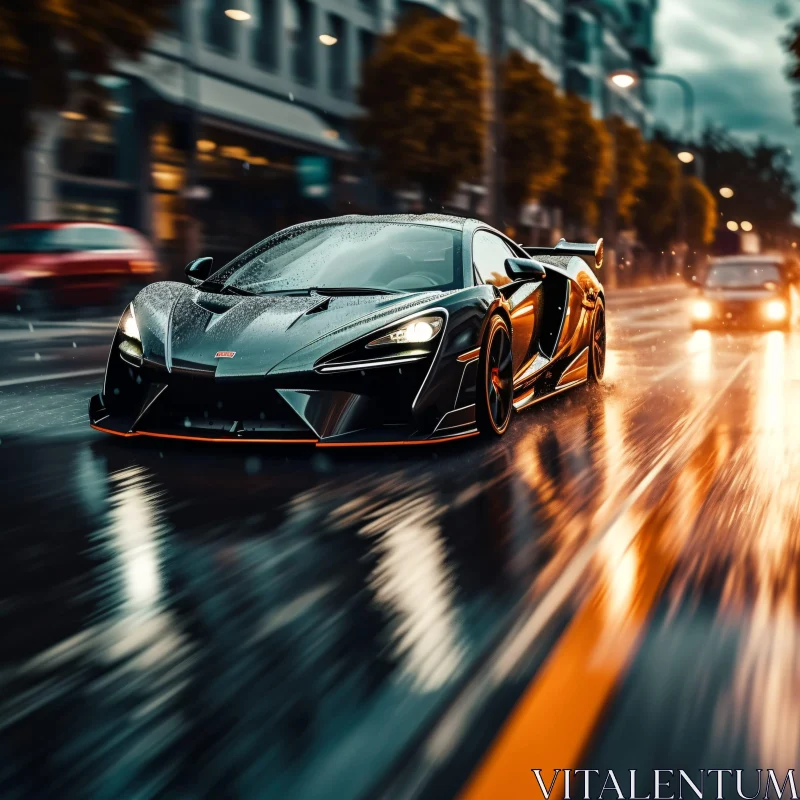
[554,94,613,233]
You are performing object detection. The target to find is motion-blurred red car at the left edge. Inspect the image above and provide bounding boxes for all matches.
[0,222,160,312]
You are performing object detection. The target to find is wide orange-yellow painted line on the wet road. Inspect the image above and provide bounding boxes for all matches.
[461,432,714,800]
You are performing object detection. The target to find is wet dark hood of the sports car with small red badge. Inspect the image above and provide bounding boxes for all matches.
[133,283,442,377]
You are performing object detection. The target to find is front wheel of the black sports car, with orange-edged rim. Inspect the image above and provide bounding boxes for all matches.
[476,314,514,436]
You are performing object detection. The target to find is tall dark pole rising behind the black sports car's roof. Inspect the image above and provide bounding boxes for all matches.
[486,0,505,231]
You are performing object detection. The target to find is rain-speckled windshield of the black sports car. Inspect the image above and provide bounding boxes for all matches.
[212,222,463,293]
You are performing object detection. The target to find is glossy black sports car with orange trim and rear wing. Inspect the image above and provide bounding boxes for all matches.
[89,214,606,446]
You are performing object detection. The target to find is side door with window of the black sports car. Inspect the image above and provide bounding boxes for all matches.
[472,230,539,375]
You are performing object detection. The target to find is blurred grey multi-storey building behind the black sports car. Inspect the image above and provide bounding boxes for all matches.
[17,0,657,263]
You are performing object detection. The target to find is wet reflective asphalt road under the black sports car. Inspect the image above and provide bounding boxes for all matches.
[0,288,800,798]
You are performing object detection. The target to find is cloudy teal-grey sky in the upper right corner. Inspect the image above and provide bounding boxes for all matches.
[653,0,800,158]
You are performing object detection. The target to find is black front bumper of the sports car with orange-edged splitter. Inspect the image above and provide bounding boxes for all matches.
[89,355,476,447]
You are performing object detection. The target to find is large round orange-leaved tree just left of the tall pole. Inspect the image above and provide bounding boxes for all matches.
[357,13,486,208]
